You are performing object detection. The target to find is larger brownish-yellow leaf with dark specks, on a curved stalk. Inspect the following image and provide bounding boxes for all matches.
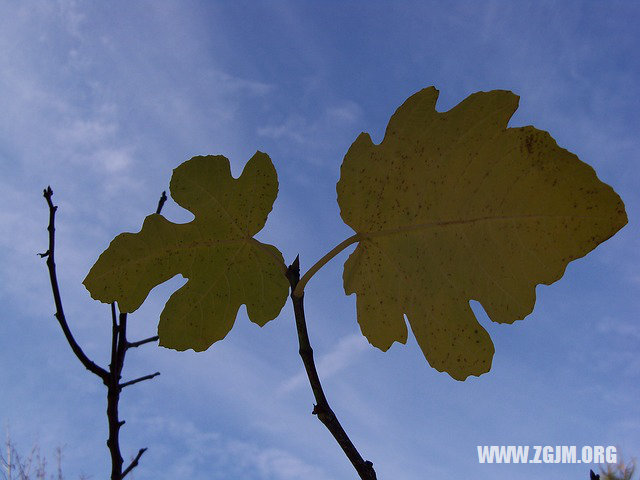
[337,87,627,380]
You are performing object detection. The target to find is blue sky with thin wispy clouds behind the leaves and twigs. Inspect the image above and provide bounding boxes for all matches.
[0,1,640,480]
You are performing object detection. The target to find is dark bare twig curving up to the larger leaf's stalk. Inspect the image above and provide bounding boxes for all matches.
[287,257,376,480]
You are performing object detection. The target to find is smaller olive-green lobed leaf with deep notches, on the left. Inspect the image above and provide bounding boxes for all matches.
[84,152,289,351]
